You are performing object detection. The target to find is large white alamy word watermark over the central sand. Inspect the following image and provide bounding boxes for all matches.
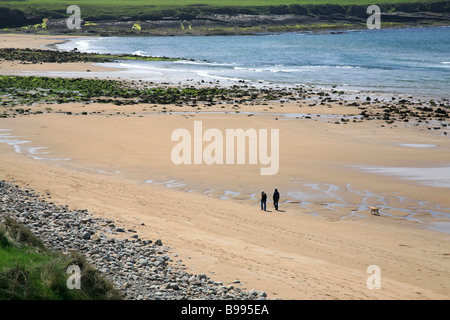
[170,121,280,175]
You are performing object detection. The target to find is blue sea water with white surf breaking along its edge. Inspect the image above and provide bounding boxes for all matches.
[59,27,450,98]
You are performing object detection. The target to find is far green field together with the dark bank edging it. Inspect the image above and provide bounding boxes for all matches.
[0,0,450,27]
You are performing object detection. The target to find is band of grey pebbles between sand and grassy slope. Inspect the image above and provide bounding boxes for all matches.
[0,180,267,300]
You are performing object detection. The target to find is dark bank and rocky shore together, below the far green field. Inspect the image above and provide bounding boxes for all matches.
[0,0,450,36]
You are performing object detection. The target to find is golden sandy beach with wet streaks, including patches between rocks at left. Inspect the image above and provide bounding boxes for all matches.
[0,35,450,300]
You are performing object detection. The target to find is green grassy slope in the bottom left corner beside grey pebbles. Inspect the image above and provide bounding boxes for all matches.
[0,217,123,300]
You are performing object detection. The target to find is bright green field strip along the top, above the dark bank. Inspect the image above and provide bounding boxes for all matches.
[0,0,442,20]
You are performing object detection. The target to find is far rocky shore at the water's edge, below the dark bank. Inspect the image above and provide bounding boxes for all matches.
[43,12,450,37]
